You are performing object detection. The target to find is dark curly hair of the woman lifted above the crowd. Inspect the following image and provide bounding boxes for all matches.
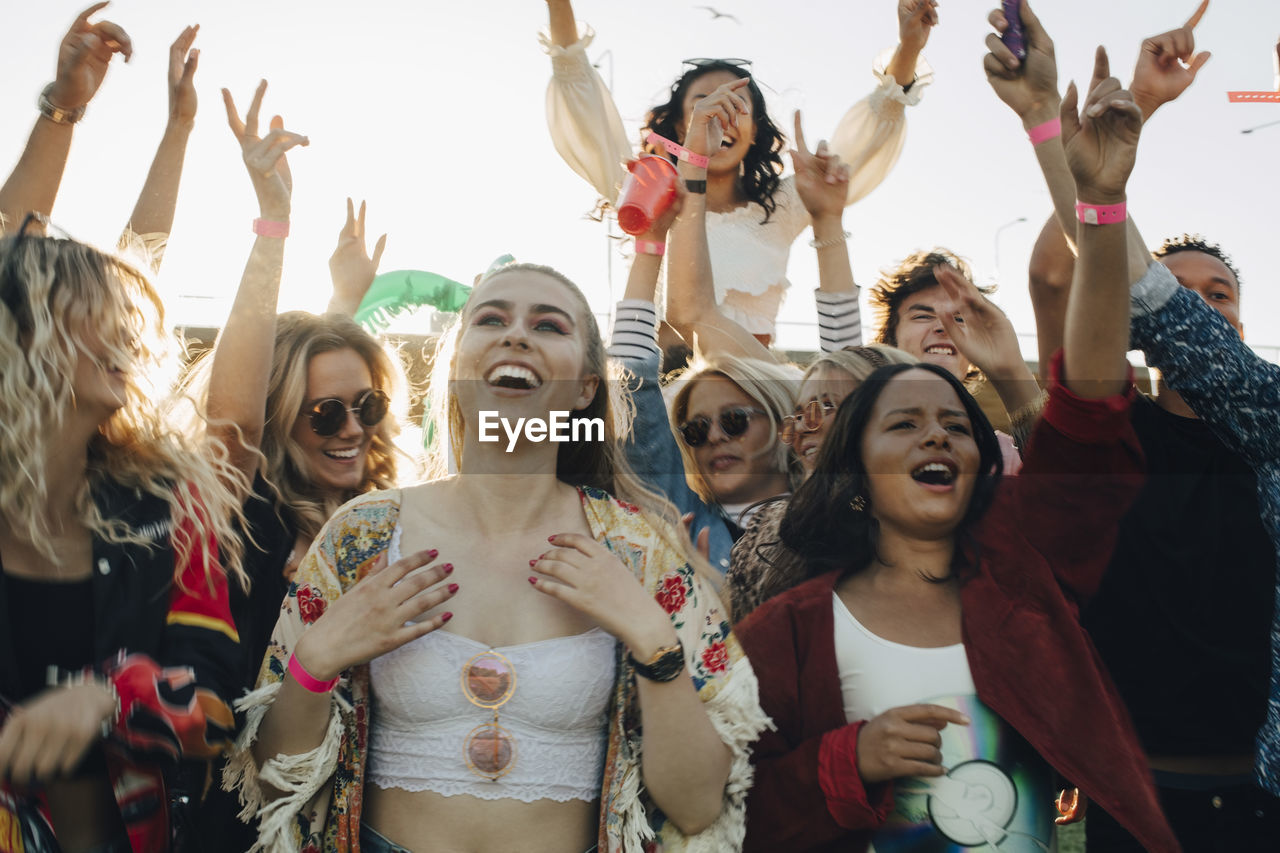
[640,61,786,224]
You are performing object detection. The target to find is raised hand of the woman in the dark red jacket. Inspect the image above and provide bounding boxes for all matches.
[1062,46,1142,204]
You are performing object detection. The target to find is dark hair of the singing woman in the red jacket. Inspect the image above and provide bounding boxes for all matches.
[778,364,1004,580]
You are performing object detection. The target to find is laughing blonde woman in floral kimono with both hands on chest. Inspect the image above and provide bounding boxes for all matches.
[227,266,765,853]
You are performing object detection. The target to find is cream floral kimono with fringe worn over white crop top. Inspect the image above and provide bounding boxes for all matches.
[223,488,769,853]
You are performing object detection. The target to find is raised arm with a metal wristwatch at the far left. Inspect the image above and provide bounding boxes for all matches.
[0,3,133,231]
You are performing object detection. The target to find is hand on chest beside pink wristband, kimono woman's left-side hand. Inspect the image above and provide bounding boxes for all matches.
[293,551,458,681]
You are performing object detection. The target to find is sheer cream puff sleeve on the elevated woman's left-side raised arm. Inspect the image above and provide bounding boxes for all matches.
[538,26,635,202]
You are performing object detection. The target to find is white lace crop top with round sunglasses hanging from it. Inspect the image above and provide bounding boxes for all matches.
[369,530,617,803]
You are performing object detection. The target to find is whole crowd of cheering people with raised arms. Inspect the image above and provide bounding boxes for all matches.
[0,0,1280,853]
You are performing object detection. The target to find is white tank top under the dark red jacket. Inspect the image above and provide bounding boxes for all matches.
[831,593,978,722]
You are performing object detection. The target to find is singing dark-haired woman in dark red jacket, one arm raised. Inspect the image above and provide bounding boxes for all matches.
[739,49,1179,853]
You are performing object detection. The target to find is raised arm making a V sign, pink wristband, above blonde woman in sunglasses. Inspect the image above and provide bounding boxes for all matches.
[207,79,308,489]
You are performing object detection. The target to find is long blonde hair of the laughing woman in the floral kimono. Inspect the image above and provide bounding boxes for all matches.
[428,264,719,578]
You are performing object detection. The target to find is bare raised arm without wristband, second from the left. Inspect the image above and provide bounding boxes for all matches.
[120,24,200,272]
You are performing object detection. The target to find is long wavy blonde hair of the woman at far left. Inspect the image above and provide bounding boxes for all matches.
[0,229,247,584]
